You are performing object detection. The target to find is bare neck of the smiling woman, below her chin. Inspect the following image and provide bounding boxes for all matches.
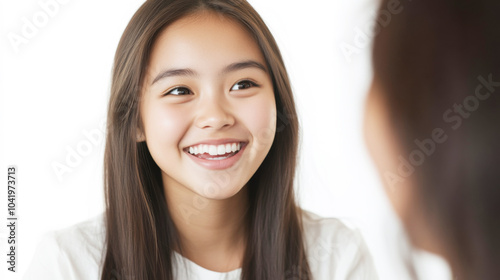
[164,178,249,272]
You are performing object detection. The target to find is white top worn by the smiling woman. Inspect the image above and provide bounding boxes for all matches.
[24,211,378,280]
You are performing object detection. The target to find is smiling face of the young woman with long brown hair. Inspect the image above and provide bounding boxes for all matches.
[138,12,276,199]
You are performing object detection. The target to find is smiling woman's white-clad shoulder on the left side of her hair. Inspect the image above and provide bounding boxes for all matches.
[23,214,105,280]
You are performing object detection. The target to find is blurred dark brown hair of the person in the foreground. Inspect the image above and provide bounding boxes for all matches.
[373,0,500,280]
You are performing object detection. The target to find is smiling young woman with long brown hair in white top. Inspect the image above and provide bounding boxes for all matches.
[23,0,377,280]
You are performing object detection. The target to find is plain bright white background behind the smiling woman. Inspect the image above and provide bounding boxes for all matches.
[0,0,448,280]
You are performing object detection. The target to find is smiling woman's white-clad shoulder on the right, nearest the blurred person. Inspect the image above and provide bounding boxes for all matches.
[302,210,378,280]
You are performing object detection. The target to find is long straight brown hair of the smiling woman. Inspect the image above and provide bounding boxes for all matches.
[102,0,311,280]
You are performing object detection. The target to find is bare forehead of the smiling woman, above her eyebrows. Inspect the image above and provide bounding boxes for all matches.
[149,12,266,82]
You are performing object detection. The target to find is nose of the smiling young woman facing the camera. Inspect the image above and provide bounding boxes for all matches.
[196,96,235,130]
